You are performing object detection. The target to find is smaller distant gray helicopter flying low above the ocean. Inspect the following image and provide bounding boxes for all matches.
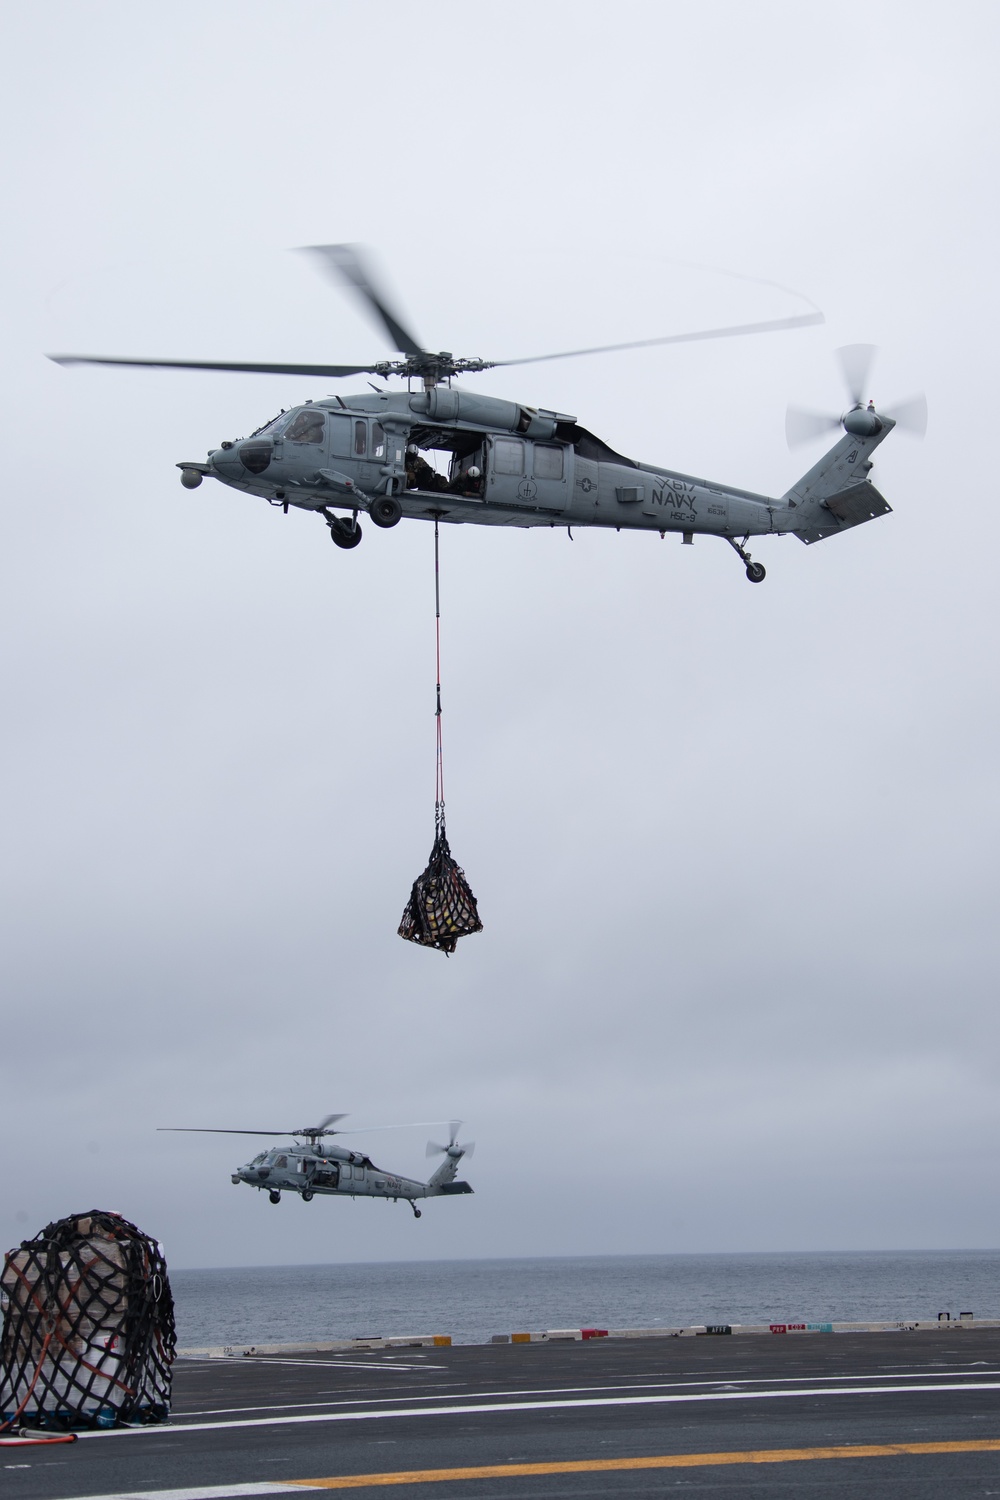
[159,1115,475,1218]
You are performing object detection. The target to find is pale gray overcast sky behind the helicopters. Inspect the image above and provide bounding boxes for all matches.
[0,0,1000,1266]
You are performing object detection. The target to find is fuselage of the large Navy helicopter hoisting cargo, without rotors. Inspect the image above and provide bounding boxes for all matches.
[178,386,894,575]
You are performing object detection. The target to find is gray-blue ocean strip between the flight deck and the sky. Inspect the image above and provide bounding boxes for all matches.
[171,1250,1000,1349]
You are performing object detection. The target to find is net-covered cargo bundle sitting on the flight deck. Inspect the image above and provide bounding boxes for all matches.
[0,1211,175,1433]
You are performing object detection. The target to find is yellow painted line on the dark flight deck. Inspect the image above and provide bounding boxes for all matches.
[293,1437,1000,1490]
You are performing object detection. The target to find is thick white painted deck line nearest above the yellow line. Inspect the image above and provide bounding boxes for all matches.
[79,1380,1000,1442]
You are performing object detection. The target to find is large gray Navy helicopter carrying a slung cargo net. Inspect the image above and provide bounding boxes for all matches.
[49,245,927,584]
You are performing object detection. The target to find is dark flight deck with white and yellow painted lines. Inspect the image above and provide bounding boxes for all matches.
[0,1326,1000,1500]
